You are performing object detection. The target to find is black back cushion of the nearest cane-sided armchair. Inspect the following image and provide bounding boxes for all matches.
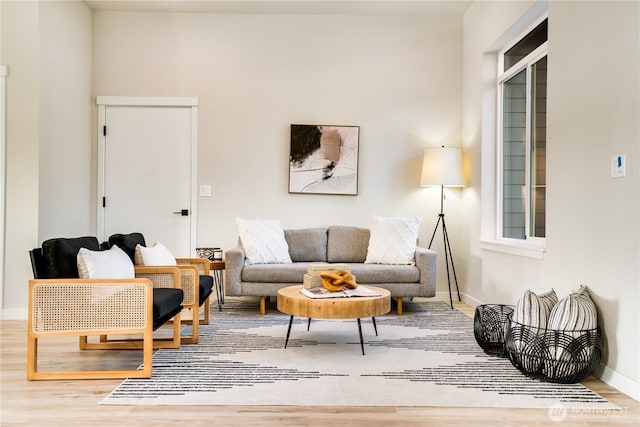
[42,236,100,279]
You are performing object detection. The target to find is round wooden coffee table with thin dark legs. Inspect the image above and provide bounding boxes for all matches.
[278,285,391,355]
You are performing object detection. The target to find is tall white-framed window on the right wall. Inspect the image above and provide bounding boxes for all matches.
[497,19,547,240]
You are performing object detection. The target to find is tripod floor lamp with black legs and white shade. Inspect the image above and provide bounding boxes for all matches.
[420,146,464,309]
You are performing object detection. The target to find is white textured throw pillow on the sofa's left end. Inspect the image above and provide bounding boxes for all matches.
[236,218,291,264]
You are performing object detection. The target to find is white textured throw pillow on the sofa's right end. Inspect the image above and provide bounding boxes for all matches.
[364,216,420,265]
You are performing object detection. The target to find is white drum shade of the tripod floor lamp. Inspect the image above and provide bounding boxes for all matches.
[420,147,464,187]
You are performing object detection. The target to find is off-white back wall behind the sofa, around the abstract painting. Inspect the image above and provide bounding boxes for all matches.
[93,12,462,298]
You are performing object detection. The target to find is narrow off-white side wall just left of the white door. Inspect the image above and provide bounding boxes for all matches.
[36,1,96,241]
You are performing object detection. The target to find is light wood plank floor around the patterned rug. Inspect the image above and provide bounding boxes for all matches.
[0,304,640,427]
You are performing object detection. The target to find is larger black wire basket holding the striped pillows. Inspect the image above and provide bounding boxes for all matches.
[505,320,604,384]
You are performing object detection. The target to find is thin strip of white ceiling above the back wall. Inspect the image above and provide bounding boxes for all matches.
[85,0,472,15]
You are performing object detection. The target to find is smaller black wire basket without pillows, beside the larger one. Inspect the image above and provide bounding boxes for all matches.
[473,304,513,357]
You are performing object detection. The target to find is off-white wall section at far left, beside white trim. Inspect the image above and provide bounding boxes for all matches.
[0,1,39,316]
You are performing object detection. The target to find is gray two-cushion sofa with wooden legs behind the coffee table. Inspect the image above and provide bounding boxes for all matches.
[224,226,437,314]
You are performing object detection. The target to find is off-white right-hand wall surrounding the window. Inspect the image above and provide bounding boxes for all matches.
[463,1,640,399]
